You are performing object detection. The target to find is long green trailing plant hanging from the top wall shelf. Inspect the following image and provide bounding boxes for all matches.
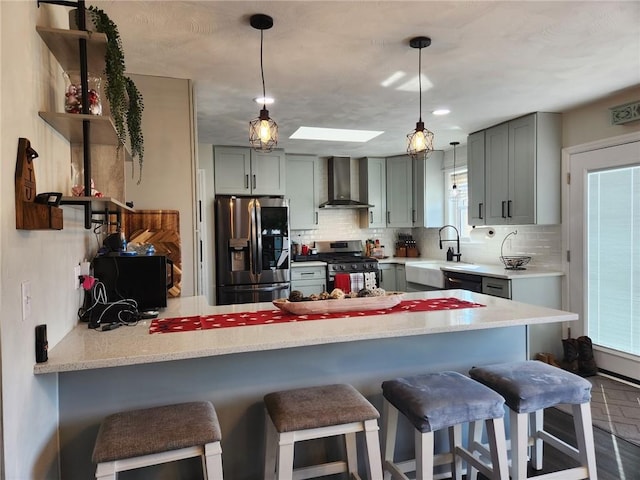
[76,6,144,184]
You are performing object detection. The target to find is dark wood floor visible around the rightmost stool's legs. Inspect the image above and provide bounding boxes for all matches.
[478,408,640,480]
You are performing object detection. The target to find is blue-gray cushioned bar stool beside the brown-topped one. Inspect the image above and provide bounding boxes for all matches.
[382,372,509,480]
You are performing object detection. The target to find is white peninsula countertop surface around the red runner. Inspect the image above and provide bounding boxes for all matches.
[34,290,578,374]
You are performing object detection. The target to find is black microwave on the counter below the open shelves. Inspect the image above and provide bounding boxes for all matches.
[93,253,173,311]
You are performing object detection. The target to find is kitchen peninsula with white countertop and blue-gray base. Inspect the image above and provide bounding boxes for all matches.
[40,290,578,480]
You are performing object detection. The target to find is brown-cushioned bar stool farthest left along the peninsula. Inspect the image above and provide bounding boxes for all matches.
[93,402,222,480]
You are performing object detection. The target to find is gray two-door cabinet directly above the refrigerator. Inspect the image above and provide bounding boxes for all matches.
[214,147,286,195]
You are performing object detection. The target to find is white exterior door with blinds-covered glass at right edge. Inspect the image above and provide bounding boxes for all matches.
[564,134,640,379]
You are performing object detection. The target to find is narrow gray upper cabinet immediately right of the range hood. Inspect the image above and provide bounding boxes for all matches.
[358,157,387,228]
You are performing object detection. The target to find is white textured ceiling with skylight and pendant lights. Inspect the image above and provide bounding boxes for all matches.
[91,0,640,157]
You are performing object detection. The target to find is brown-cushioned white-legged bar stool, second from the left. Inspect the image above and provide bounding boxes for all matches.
[264,385,382,480]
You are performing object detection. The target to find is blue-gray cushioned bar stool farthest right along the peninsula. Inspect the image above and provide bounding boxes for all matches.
[469,360,597,480]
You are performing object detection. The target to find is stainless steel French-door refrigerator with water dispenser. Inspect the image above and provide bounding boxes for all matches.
[215,196,291,305]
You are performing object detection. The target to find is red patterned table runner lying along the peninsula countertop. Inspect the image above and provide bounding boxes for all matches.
[149,297,484,333]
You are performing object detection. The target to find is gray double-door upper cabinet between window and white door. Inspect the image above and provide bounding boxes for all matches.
[468,112,562,225]
